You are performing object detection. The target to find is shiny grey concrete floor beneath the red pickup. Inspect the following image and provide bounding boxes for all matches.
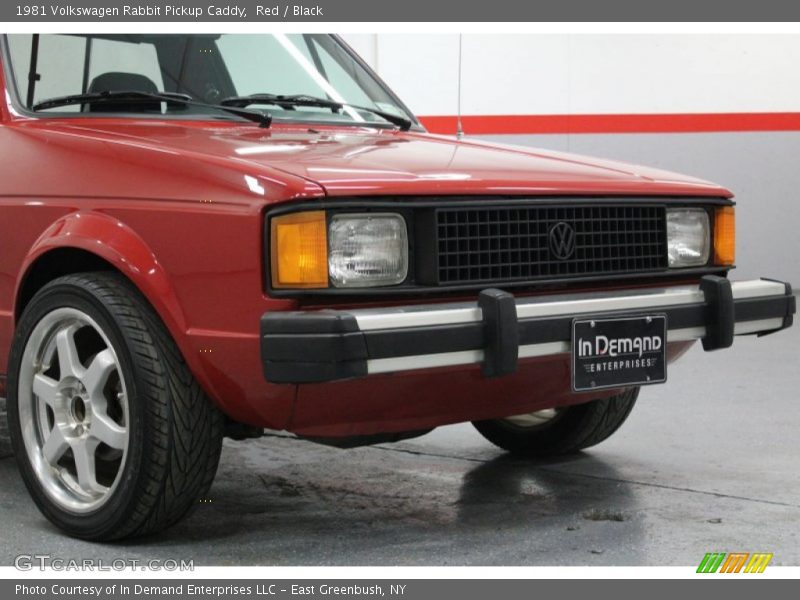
[0,327,800,565]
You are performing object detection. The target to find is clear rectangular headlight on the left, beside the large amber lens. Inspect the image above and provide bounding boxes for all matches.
[328,214,408,288]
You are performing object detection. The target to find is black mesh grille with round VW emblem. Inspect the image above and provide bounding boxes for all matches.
[435,206,667,285]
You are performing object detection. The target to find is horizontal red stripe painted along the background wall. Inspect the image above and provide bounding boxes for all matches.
[419,113,800,135]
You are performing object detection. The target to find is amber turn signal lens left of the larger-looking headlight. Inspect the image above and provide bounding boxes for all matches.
[270,210,328,288]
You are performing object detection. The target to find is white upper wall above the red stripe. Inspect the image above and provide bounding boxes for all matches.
[344,34,800,115]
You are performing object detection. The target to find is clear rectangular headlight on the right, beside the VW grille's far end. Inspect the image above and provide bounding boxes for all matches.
[667,208,711,268]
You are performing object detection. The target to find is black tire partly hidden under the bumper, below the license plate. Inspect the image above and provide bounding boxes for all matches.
[473,387,639,457]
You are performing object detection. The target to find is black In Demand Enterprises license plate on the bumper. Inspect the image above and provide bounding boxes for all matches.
[572,314,667,392]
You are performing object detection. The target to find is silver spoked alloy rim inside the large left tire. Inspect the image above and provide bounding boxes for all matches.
[19,308,128,512]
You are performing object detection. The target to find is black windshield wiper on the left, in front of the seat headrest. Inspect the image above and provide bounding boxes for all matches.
[31,90,272,127]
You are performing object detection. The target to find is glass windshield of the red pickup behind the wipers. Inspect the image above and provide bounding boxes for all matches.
[7,34,414,125]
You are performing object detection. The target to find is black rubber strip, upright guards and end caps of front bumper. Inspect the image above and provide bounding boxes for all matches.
[261,275,796,384]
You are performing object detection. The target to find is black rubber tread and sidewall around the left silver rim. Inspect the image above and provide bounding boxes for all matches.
[8,272,224,541]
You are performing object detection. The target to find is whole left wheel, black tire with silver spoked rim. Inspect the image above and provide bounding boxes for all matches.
[8,273,223,540]
